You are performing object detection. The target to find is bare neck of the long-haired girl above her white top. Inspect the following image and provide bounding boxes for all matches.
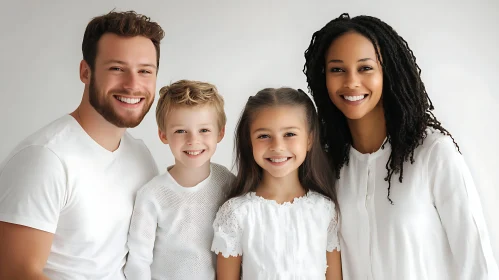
[256,170,305,204]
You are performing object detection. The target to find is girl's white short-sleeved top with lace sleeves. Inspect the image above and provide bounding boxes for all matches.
[212,191,339,280]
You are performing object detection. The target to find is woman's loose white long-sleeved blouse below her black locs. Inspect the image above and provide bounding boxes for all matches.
[338,129,499,280]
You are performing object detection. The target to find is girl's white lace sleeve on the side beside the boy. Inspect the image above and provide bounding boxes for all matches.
[211,198,243,258]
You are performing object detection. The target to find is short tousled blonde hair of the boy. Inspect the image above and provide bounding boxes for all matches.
[156,80,227,132]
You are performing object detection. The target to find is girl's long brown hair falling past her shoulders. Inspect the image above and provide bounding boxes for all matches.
[229,88,339,209]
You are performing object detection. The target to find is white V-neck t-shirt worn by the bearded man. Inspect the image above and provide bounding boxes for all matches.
[0,115,158,280]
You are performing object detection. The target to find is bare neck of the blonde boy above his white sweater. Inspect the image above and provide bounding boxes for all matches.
[168,161,210,188]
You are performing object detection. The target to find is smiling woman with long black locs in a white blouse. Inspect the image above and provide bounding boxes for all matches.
[304,14,499,280]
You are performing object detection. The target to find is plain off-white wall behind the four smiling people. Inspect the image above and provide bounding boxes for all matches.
[0,0,499,266]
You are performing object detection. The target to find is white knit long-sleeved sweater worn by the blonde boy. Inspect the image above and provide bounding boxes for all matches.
[125,163,235,280]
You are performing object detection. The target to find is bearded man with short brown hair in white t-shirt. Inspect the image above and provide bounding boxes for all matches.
[0,9,164,280]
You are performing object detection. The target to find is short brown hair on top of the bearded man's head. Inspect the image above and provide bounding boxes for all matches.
[82,11,165,70]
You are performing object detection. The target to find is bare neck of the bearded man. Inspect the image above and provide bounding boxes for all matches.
[70,102,126,152]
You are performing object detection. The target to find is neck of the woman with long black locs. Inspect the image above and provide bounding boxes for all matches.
[348,101,386,154]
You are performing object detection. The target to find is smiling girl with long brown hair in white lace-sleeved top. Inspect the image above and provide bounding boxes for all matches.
[212,88,341,280]
